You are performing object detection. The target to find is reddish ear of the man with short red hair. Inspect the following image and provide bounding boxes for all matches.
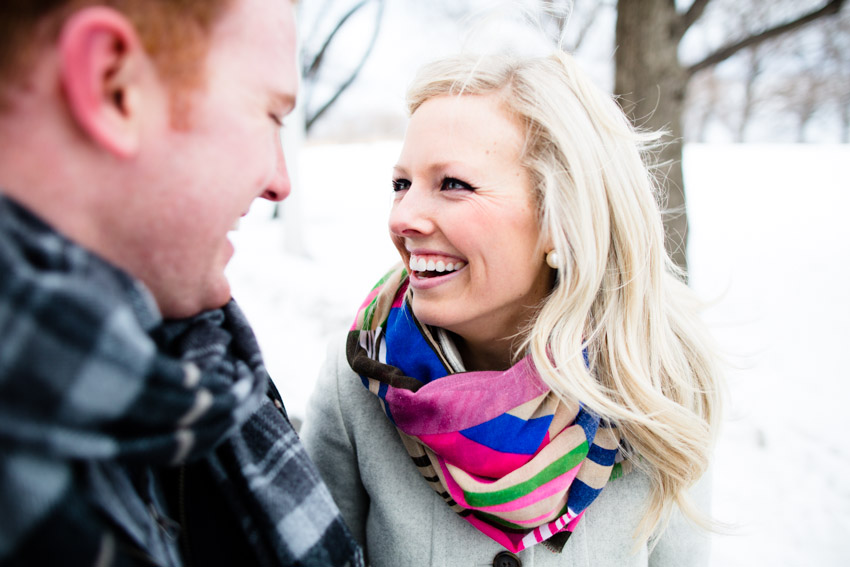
[59,7,147,157]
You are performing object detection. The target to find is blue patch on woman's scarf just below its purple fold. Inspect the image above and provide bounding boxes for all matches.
[460,414,553,455]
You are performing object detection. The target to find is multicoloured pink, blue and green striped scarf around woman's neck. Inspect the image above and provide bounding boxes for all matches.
[347,268,625,553]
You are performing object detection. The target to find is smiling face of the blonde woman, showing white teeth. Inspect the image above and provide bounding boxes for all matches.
[389,95,552,360]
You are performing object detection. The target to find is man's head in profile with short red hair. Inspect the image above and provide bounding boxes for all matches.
[0,0,297,317]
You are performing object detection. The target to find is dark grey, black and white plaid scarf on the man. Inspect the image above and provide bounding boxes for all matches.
[0,196,363,566]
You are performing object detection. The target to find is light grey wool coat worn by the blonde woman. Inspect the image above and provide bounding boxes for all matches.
[302,338,710,567]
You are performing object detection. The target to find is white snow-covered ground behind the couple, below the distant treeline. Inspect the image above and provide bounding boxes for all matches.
[229,142,850,567]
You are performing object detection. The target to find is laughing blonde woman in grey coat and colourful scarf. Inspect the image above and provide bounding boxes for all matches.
[304,53,719,567]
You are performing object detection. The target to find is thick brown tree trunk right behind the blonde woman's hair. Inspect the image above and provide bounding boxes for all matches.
[614,0,689,270]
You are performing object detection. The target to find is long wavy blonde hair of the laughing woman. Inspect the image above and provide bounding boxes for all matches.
[408,52,721,541]
